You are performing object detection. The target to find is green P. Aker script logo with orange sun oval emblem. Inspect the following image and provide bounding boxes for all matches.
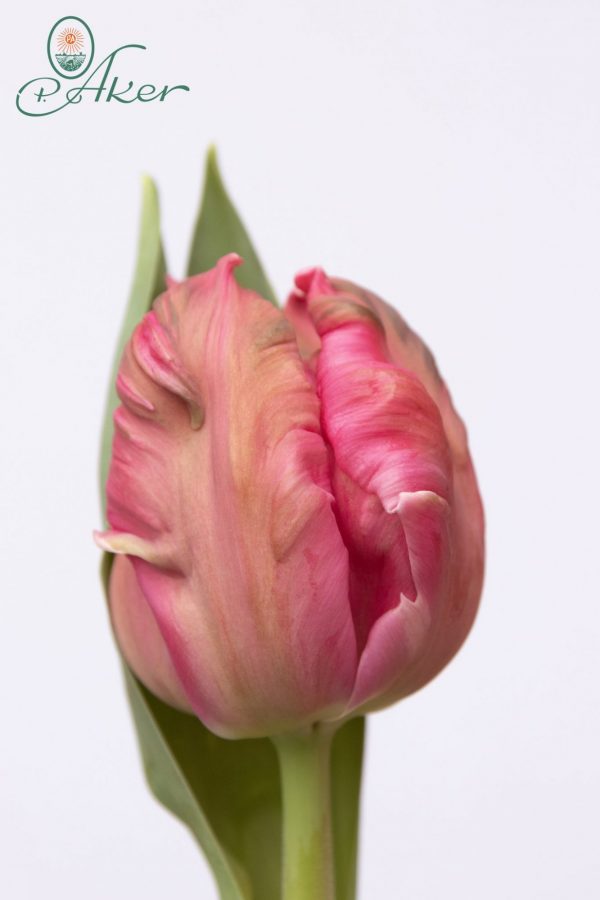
[16,16,189,117]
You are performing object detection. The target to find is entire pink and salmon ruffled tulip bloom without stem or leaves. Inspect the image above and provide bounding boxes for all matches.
[97,254,483,737]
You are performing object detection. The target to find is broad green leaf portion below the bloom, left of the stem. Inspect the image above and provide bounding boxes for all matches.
[128,675,281,900]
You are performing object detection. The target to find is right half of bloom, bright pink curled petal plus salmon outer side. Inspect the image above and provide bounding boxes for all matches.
[288,270,482,709]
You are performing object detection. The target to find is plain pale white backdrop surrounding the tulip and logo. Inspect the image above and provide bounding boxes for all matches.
[0,0,600,900]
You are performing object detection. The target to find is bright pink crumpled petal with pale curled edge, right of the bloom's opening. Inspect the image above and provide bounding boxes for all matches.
[290,270,452,707]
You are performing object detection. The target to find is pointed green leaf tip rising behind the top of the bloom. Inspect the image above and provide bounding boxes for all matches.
[188,147,277,306]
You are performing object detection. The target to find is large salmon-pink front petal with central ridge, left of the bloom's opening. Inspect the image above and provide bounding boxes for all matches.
[95,255,356,736]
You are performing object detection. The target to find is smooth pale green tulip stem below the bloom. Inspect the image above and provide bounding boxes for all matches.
[273,724,335,900]
